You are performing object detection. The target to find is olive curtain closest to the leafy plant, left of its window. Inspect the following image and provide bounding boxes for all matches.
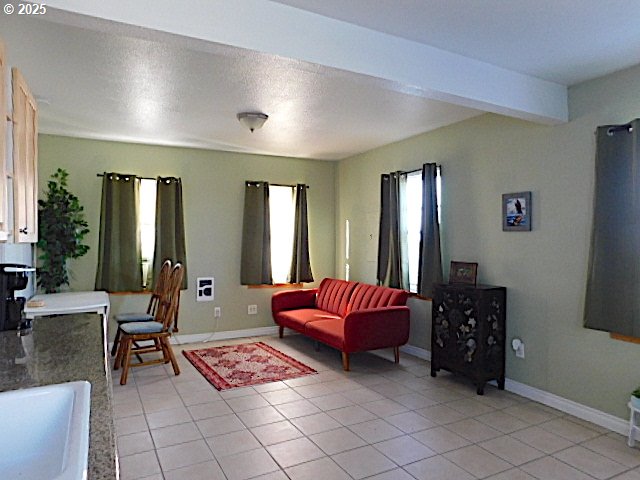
[95,173,142,292]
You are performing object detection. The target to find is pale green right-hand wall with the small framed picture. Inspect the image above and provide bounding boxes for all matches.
[336,67,640,418]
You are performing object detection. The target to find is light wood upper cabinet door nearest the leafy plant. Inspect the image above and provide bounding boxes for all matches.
[12,68,38,243]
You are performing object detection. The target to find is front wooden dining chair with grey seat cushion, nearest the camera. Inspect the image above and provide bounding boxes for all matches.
[113,263,184,385]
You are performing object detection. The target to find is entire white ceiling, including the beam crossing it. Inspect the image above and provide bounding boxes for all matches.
[0,0,640,160]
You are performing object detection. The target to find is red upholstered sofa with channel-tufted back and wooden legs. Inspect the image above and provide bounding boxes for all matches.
[271,278,409,371]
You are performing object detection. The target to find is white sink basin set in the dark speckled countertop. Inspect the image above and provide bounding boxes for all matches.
[0,381,91,480]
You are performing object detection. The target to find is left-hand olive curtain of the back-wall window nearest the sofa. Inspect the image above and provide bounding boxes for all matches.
[240,182,273,285]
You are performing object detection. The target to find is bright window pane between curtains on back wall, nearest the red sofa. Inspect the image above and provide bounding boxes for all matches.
[269,185,295,283]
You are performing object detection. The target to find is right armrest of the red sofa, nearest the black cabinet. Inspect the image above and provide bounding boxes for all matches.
[344,306,409,352]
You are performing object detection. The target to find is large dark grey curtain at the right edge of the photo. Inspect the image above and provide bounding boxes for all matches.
[584,119,640,337]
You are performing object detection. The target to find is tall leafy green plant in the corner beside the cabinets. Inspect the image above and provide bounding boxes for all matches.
[38,168,89,293]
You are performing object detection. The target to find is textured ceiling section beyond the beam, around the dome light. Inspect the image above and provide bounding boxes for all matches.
[0,12,481,160]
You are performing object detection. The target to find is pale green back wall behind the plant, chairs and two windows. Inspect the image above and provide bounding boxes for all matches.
[38,135,337,334]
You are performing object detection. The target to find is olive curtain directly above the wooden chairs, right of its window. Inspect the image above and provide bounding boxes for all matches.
[153,177,188,290]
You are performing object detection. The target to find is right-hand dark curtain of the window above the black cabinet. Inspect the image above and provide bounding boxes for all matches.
[418,163,442,298]
